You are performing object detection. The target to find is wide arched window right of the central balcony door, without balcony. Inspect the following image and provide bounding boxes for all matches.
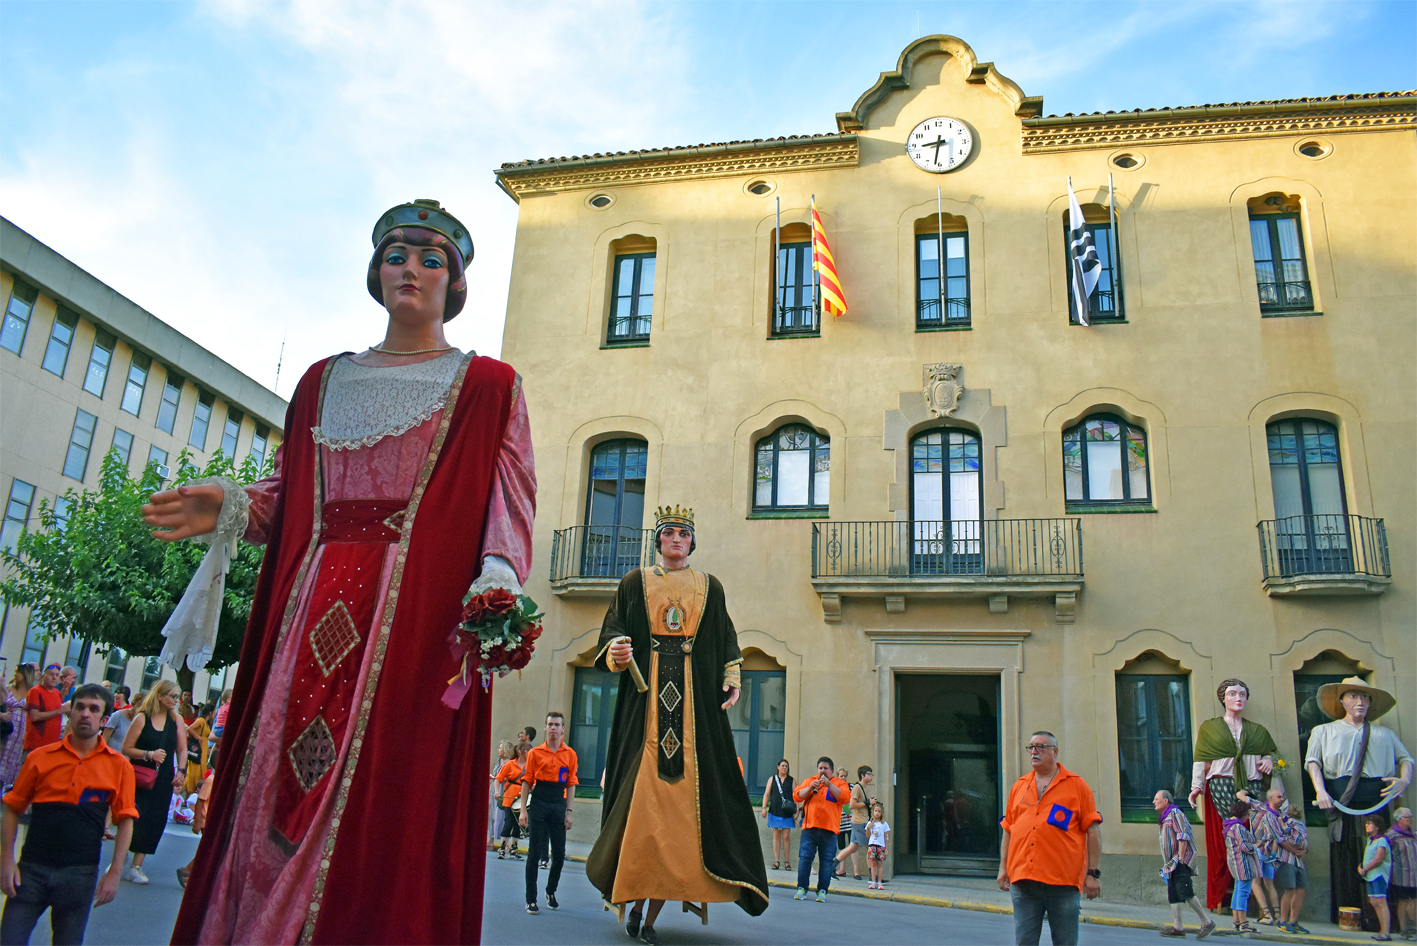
[1063,414,1151,503]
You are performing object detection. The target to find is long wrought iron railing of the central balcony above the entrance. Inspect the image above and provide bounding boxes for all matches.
[812,518,1083,579]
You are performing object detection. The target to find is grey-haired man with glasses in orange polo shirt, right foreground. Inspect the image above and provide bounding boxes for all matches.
[999,732,1102,946]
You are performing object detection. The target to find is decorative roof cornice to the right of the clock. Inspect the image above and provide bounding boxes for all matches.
[1023,92,1417,154]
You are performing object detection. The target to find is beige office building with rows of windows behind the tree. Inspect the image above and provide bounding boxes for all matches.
[0,218,286,700]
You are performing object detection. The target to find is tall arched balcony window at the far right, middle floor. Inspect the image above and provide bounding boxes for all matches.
[1264,418,1353,575]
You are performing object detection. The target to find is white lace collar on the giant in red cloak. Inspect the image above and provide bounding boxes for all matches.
[310,348,462,450]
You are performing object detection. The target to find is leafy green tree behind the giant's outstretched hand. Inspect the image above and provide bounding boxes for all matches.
[0,450,269,690]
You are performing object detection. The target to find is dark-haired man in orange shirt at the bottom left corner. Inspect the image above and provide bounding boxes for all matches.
[0,684,137,943]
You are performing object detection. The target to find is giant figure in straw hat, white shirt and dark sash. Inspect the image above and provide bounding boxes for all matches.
[1304,677,1413,930]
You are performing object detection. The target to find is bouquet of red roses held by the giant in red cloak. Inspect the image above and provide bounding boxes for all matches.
[444,588,541,710]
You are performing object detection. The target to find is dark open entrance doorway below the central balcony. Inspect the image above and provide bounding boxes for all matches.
[887,673,1000,877]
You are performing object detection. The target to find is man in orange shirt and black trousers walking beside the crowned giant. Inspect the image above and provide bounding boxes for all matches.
[519,712,580,916]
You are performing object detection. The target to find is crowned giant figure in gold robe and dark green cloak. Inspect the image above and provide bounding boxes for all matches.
[585,507,768,943]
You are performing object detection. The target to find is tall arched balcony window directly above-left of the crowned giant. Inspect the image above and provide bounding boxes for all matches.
[581,440,649,578]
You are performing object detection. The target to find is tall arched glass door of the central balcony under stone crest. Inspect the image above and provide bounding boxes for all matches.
[910,429,983,575]
